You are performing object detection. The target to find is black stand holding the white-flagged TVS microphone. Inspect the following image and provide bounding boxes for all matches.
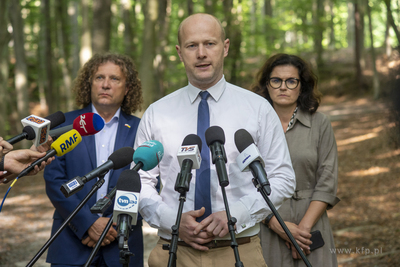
[163,165,193,267]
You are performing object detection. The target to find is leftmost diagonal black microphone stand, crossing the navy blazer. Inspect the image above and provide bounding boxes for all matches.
[26,176,108,267]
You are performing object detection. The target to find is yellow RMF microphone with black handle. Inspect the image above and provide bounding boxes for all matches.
[18,130,82,178]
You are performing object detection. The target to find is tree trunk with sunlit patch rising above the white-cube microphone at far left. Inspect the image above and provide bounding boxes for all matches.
[9,1,29,125]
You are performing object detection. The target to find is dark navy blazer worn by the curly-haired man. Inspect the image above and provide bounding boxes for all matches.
[44,105,143,267]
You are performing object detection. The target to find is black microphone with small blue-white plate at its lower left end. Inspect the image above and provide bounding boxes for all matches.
[60,148,134,197]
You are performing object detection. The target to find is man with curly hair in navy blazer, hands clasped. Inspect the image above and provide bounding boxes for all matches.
[44,53,143,267]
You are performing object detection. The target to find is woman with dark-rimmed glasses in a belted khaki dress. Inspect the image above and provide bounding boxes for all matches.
[252,54,339,267]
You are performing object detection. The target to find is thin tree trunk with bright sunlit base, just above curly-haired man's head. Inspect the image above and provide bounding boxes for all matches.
[79,0,93,66]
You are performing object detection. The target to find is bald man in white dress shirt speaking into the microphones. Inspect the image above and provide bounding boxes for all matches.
[134,14,295,267]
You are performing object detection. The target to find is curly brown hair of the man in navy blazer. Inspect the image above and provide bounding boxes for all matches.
[73,53,143,114]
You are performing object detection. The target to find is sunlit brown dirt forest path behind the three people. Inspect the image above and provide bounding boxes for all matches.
[0,98,400,267]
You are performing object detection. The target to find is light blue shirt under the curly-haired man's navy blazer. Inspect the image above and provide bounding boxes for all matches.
[92,104,121,204]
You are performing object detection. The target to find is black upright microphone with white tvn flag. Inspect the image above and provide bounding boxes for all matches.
[113,170,142,249]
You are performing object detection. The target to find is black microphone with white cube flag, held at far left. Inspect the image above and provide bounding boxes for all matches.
[7,111,65,147]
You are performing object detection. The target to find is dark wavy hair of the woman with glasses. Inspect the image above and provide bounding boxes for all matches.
[251,53,321,114]
